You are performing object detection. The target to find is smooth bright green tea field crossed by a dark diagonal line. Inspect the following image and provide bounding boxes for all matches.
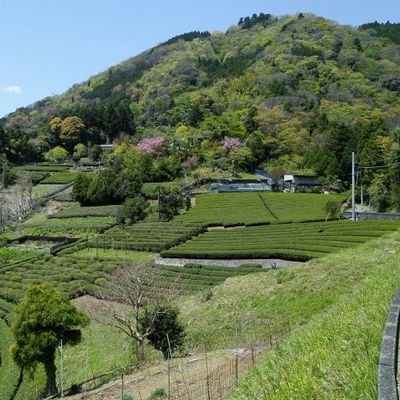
[175,193,342,226]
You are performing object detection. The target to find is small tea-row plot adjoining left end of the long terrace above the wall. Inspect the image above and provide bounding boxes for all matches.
[87,222,203,252]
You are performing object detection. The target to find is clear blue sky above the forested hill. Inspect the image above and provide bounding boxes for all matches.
[0,0,400,117]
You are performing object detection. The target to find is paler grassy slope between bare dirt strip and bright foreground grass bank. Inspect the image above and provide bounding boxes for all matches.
[181,228,400,360]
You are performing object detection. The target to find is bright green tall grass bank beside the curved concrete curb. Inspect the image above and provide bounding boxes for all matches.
[225,232,400,400]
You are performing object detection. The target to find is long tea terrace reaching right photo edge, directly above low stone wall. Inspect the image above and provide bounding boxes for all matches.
[161,221,400,261]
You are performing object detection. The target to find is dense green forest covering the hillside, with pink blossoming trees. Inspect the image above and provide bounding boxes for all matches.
[0,14,400,209]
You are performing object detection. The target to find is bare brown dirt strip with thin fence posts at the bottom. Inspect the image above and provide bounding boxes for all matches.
[68,349,255,400]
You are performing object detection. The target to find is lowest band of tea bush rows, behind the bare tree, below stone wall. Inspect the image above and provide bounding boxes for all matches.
[0,249,263,318]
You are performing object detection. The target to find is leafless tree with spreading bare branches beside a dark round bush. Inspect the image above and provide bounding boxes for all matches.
[90,263,179,361]
